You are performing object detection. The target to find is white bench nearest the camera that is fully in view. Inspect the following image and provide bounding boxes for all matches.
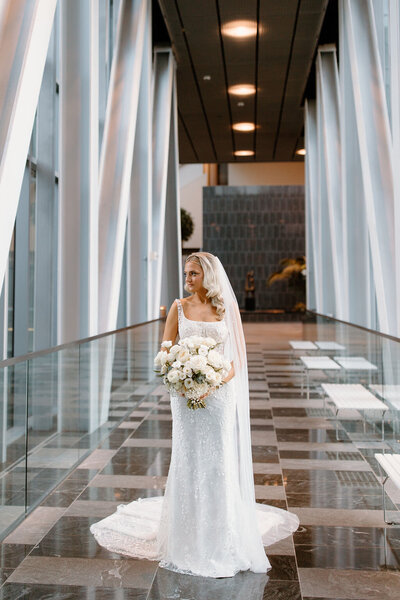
[321,383,388,441]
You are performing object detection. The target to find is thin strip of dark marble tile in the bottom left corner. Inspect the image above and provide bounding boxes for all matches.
[0,583,148,600]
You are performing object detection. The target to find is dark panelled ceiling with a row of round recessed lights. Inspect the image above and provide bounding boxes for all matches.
[159,0,328,163]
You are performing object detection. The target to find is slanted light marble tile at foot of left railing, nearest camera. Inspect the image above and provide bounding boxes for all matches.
[3,506,65,544]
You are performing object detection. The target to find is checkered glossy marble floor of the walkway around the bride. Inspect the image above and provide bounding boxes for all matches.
[0,323,400,600]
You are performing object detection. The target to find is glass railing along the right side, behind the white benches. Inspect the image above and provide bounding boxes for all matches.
[300,311,400,452]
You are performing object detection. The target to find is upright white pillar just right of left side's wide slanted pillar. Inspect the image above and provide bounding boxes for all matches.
[127,2,152,324]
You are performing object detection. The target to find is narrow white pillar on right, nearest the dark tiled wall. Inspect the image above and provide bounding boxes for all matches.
[305,100,323,312]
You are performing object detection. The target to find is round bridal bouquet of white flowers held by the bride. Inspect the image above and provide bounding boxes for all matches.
[154,335,231,409]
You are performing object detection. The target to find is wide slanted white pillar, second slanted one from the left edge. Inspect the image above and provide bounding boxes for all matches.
[98,0,149,333]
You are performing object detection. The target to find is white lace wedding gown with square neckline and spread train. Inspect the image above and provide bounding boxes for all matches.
[91,300,299,577]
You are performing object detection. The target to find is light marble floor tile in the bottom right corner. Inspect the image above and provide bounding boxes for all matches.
[299,569,400,600]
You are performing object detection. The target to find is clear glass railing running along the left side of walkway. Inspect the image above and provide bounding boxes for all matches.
[0,320,164,539]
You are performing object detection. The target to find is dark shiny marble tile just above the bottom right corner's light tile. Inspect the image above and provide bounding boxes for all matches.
[295,545,400,571]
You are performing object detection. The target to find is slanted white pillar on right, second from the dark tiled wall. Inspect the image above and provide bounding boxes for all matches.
[316,45,344,319]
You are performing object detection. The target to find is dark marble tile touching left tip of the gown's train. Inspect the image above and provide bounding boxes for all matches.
[30,517,122,559]
